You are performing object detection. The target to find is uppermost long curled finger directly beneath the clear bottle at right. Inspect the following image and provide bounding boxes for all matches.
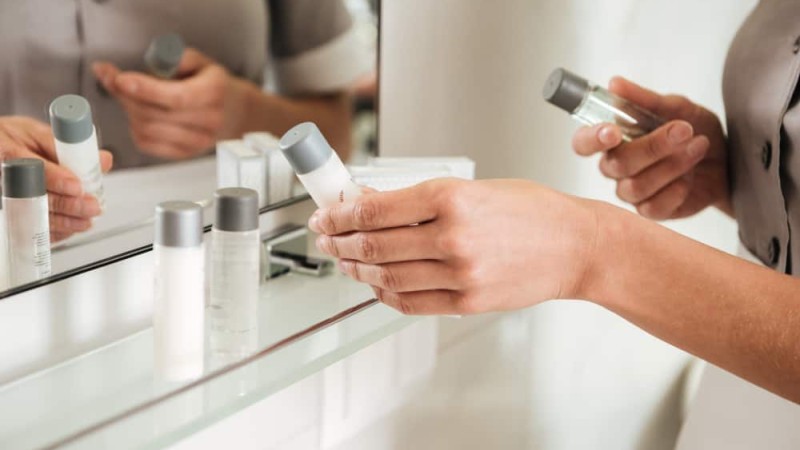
[600,120,694,180]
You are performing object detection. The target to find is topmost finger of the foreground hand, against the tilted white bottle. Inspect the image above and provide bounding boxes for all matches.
[308,182,439,235]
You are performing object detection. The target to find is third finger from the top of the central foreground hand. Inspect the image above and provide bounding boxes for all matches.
[339,259,462,292]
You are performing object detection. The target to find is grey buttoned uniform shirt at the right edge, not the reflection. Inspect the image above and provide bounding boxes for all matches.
[723,0,800,273]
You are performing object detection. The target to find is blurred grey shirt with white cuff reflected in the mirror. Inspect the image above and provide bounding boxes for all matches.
[0,0,365,169]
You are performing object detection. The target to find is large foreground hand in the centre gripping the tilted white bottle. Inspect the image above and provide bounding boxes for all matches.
[309,179,596,314]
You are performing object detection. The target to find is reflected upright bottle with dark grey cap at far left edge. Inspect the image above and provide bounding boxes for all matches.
[2,158,51,287]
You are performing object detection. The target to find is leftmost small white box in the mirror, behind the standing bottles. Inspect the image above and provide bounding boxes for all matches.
[217,140,267,206]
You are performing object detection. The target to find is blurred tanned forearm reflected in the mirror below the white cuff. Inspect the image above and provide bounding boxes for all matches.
[226,79,352,160]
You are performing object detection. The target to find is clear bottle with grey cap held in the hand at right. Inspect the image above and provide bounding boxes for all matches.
[542,68,664,142]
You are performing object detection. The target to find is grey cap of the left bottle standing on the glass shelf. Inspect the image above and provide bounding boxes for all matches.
[155,201,203,247]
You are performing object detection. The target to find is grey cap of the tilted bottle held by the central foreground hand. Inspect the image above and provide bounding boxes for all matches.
[279,122,333,175]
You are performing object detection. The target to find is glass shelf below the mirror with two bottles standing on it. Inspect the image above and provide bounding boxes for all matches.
[0,273,414,449]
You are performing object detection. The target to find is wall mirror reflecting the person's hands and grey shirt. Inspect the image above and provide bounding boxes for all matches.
[0,0,379,296]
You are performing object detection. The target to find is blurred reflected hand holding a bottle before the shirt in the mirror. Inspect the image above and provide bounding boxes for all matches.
[92,48,237,160]
